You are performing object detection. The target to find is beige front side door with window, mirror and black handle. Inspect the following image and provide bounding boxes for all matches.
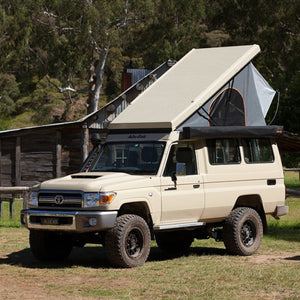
[161,143,204,224]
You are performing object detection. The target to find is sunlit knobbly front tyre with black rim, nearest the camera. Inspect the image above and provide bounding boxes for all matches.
[105,214,151,268]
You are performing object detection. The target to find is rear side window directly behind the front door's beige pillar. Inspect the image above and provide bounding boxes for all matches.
[206,139,241,165]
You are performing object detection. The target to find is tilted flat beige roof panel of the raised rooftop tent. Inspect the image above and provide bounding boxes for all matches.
[109,45,260,130]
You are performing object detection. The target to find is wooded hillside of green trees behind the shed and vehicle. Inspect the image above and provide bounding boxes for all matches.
[0,0,300,132]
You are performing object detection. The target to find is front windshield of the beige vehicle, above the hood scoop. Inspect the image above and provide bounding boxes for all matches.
[89,142,165,175]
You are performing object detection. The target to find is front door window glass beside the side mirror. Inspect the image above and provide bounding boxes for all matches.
[163,144,197,176]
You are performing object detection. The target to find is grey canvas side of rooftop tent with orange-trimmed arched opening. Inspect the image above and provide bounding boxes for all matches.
[179,63,275,129]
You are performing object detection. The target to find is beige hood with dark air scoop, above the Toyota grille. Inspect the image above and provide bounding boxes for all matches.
[39,172,150,192]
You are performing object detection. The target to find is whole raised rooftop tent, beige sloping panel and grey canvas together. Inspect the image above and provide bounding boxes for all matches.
[109,45,275,131]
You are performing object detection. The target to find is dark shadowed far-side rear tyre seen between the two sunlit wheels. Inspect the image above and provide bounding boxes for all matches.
[155,230,194,254]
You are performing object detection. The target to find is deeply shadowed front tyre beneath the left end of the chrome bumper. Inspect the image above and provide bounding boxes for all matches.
[29,230,73,261]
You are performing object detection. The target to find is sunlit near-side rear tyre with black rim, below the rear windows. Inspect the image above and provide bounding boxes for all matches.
[223,207,263,256]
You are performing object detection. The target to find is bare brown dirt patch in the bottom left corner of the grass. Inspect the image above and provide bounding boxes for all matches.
[0,266,133,300]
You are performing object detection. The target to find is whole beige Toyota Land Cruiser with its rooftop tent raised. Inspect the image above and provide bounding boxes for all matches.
[21,45,288,267]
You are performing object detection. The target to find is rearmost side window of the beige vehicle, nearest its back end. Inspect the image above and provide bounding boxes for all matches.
[242,138,274,164]
